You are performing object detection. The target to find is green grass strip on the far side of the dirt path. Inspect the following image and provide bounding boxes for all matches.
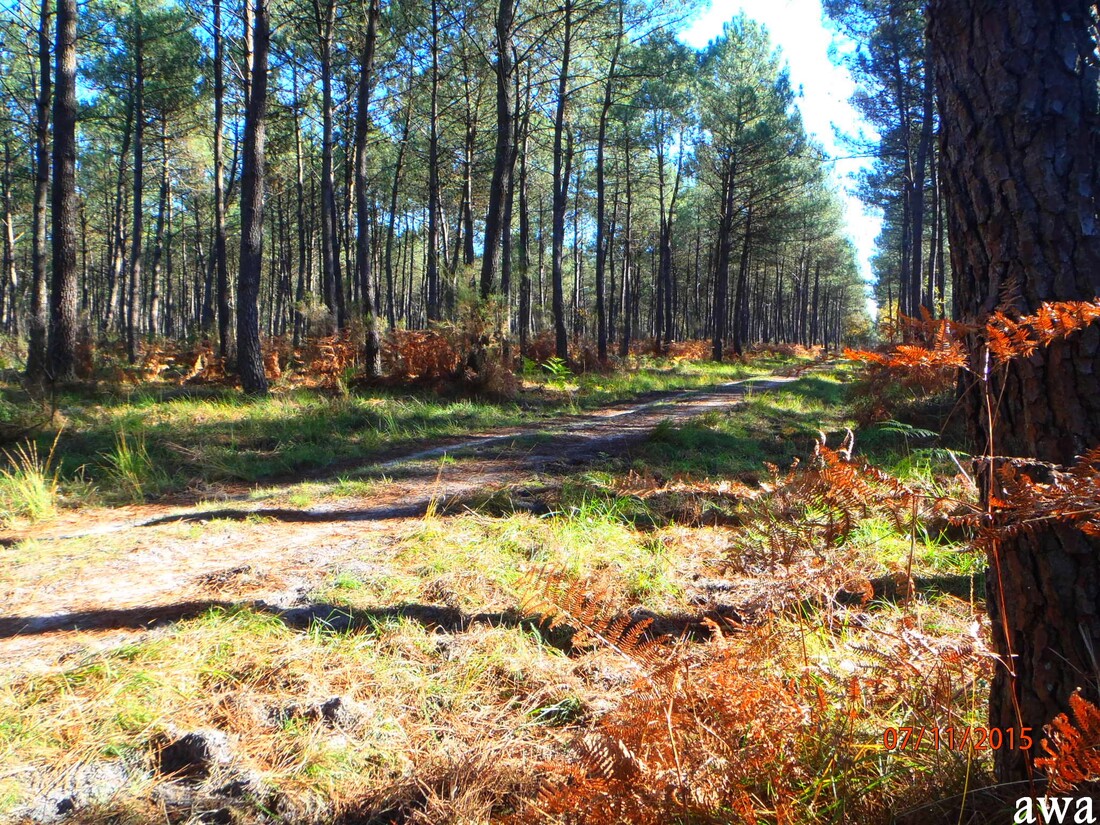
[0,358,791,504]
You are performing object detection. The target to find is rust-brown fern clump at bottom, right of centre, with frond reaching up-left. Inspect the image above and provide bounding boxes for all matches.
[513,570,813,825]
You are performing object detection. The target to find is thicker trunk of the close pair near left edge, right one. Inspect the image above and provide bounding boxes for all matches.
[46,0,80,382]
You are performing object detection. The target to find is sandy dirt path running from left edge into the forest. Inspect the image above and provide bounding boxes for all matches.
[0,376,809,670]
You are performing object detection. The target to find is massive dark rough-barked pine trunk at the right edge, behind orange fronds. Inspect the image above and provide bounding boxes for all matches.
[930,0,1100,781]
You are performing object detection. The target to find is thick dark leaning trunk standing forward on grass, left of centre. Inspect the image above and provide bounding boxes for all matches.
[237,0,271,395]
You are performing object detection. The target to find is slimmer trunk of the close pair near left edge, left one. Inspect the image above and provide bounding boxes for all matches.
[26,0,52,382]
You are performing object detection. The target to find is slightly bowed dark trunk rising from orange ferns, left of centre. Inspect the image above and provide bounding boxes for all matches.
[355,0,382,378]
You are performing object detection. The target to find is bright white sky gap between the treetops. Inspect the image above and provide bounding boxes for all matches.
[680,0,882,288]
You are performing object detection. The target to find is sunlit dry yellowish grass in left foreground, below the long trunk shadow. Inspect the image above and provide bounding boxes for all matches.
[0,609,583,822]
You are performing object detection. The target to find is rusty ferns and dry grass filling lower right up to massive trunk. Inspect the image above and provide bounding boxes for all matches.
[509,570,991,825]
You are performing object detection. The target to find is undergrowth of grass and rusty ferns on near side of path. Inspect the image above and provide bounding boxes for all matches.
[8,336,1078,825]
